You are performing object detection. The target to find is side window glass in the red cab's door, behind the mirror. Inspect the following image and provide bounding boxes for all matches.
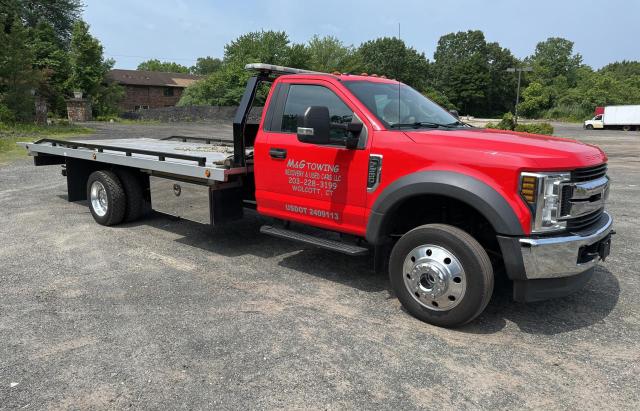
[281,84,353,144]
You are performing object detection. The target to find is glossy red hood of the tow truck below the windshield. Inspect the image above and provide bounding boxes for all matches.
[405,129,607,170]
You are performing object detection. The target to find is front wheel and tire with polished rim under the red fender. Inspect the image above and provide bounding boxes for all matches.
[389,224,494,327]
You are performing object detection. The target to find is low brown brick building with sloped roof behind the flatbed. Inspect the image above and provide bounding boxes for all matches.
[108,69,201,112]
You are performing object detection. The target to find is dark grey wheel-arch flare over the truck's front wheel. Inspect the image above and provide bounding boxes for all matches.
[366,171,525,245]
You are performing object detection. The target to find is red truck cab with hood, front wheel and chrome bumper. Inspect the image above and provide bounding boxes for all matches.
[254,65,612,325]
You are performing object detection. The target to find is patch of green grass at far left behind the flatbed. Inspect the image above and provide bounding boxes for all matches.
[0,123,93,164]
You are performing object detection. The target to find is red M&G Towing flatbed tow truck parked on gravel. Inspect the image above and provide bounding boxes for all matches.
[21,63,613,327]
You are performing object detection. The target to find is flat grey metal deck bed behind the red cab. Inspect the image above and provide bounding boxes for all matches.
[19,136,253,183]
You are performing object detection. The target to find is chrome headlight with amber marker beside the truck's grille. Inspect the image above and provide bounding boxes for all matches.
[520,172,571,233]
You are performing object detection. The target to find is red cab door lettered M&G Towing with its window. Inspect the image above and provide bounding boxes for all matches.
[256,79,372,235]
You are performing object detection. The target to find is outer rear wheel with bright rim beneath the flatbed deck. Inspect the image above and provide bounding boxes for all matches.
[87,170,127,226]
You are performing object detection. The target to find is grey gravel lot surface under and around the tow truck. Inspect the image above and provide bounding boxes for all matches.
[0,124,640,409]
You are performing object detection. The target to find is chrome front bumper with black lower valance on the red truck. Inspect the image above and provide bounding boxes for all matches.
[498,212,613,301]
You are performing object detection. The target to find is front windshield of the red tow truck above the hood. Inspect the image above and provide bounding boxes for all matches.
[344,81,463,128]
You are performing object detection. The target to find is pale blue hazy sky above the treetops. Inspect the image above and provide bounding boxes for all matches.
[84,0,640,69]
